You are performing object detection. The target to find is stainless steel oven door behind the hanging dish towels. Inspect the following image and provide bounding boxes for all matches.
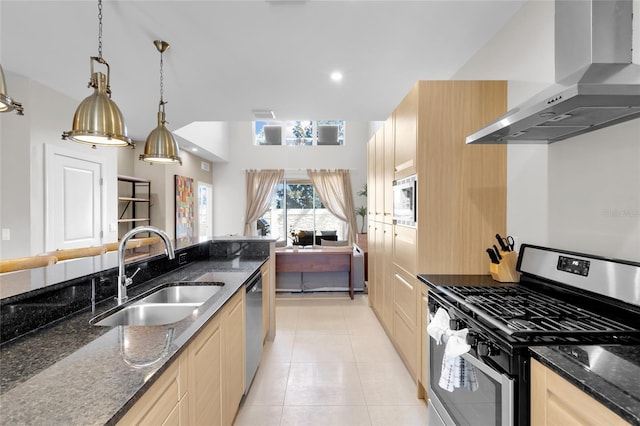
[429,312,514,426]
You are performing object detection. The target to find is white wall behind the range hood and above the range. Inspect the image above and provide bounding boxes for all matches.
[453,0,640,261]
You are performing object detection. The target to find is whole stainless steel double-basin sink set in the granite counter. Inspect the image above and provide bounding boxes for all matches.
[89,281,224,327]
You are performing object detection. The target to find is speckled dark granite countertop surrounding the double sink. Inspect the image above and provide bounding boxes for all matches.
[0,258,264,425]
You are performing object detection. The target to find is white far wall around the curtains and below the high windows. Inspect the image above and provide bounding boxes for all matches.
[213,121,371,235]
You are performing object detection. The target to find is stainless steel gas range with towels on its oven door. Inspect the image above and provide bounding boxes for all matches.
[419,245,640,426]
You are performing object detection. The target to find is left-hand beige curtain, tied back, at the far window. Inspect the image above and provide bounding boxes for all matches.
[244,170,284,236]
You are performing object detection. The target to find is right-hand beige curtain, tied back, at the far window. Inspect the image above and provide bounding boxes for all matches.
[307,169,358,244]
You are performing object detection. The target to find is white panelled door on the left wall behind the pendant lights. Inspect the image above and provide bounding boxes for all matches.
[45,148,103,251]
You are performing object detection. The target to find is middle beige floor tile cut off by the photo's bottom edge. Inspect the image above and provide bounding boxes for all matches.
[281,405,371,426]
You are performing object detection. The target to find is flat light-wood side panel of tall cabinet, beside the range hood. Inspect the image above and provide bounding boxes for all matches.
[418,81,507,274]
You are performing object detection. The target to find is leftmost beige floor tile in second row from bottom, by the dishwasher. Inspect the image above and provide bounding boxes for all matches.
[245,363,290,405]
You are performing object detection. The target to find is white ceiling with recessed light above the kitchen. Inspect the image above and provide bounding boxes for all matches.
[0,0,524,152]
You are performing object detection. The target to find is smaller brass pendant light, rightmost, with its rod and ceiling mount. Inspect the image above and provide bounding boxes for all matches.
[140,40,182,165]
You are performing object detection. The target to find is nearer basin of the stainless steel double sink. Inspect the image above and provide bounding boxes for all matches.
[90,302,198,327]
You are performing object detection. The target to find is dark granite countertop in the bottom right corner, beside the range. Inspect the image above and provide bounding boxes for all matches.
[530,345,640,425]
